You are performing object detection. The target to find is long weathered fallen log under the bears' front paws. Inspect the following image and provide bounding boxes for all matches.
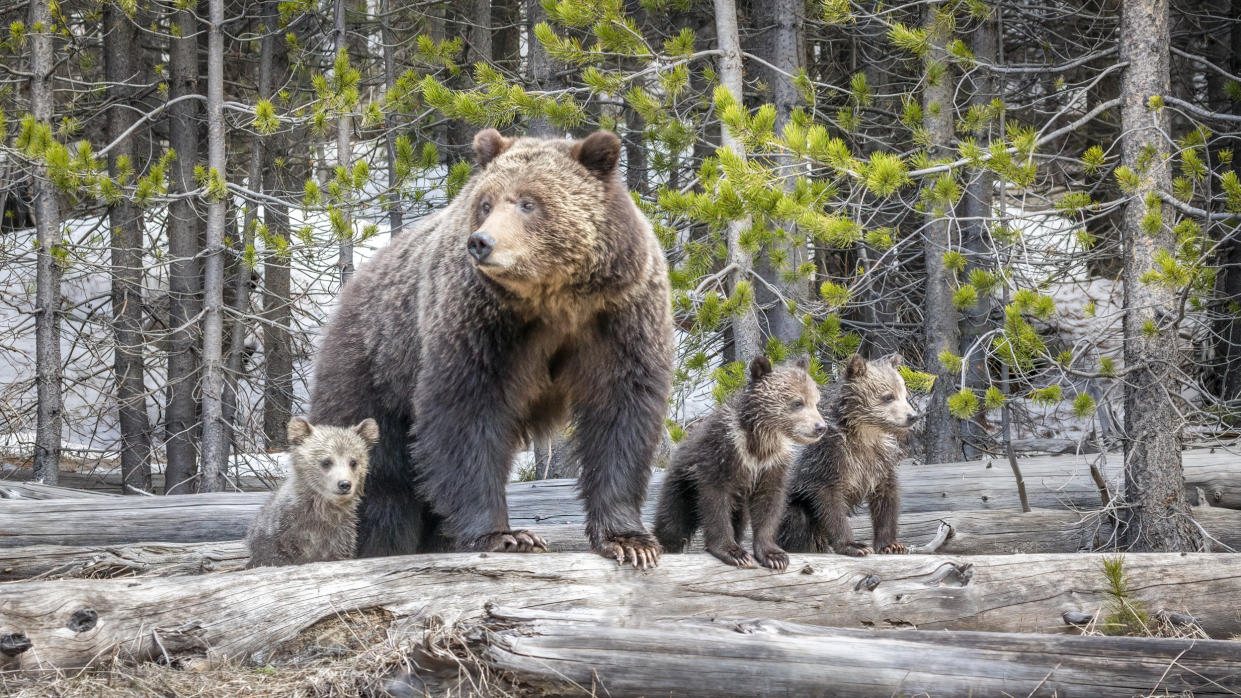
[0,553,1241,669]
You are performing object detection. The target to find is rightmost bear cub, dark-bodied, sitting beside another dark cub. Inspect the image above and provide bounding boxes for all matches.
[779,354,918,556]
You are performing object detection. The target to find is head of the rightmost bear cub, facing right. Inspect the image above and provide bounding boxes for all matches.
[840,354,920,433]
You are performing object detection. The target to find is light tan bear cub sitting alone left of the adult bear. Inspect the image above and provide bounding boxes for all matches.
[246,417,380,568]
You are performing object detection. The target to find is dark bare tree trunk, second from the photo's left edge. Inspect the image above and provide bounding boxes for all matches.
[104,2,151,494]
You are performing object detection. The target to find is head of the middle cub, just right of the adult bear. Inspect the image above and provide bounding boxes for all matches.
[741,356,828,443]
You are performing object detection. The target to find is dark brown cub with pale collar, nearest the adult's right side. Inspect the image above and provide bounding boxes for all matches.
[655,356,827,570]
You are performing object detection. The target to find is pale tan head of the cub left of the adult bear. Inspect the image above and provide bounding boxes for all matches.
[288,417,380,505]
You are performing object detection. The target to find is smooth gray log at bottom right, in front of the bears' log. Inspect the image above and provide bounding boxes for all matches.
[467,607,1241,698]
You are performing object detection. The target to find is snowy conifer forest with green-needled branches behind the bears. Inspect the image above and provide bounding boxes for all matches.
[0,0,1241,549]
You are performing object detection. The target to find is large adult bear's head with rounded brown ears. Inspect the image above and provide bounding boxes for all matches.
[462,129,650,297]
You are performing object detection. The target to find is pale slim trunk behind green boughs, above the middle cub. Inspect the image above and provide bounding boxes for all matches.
[712,0,763,361]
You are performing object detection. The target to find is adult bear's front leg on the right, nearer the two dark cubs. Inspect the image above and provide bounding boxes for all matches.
[568,304,671,569]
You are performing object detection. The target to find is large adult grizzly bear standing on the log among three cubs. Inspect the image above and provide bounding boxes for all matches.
[311,129,673,568]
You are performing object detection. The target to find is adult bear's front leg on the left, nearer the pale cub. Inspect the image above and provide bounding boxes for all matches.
[411,371,547,553]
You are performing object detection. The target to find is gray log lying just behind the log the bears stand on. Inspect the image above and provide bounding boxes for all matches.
[0,507,1241,581]
